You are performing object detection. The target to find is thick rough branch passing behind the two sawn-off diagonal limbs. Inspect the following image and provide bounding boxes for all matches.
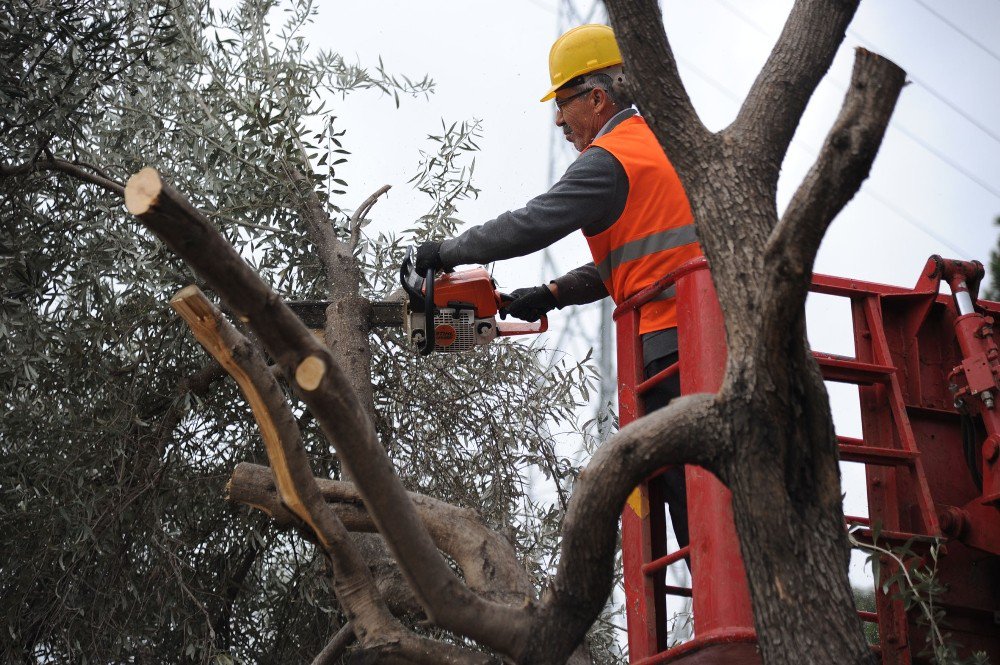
[226,462,534,603]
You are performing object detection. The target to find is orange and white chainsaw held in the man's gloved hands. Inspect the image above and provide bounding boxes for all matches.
[288,247,549,356]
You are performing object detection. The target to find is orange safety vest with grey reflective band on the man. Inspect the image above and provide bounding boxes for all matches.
[585,116,701,334]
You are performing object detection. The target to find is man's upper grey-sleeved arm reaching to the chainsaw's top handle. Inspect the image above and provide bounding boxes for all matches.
[440,146,628,267]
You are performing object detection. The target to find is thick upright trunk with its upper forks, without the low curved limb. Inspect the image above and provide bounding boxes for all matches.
[608,0,903,663]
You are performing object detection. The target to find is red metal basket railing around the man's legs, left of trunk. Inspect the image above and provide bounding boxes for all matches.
[614,259,760,665]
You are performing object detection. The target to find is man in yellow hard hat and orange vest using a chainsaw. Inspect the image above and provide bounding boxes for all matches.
[416,25,701,546]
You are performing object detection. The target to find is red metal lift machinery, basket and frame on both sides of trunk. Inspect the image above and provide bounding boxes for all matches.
[614,256,1000,665]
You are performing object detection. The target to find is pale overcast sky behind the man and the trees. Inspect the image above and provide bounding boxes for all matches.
[270,0,1000,632]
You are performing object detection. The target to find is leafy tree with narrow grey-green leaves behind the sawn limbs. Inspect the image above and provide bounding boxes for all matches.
[0,0,610,662]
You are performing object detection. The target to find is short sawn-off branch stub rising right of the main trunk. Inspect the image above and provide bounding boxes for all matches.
[764,48,906,316]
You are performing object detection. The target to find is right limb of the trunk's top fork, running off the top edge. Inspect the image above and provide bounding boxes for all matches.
[726,0,860,169]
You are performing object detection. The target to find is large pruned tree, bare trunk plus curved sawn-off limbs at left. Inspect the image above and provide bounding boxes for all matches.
[1,0,904,663]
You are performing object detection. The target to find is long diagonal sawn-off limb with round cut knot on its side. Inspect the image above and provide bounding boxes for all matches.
[125,168,531,653]
